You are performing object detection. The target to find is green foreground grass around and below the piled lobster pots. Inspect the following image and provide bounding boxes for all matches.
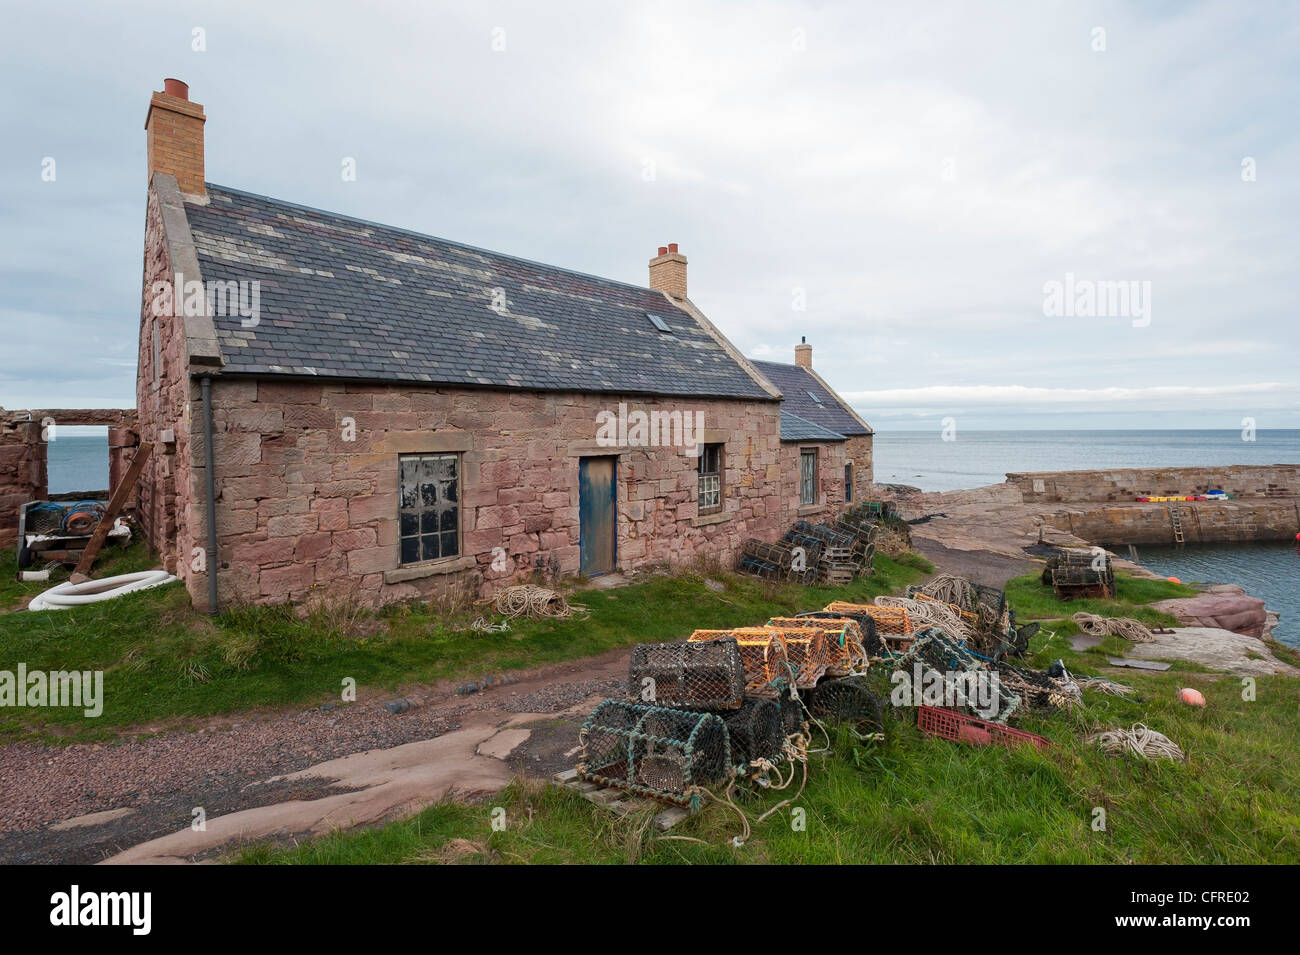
[233,561,1300,864]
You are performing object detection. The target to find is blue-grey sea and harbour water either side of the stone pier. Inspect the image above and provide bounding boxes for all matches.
[874,429,1300,647]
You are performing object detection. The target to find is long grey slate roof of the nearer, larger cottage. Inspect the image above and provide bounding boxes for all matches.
[186,185,772,400]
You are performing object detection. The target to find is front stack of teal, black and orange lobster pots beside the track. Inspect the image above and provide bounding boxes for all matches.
[577,611,883,811]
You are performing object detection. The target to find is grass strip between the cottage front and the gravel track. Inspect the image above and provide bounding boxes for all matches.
[0,544,930,743]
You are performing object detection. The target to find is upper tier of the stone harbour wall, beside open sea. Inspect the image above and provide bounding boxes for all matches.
[1006,464,1300,504]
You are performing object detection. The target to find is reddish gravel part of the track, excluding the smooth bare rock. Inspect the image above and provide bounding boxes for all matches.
[0,651,627,863]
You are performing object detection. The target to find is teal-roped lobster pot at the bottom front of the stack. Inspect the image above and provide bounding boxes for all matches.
[577,700,732,811]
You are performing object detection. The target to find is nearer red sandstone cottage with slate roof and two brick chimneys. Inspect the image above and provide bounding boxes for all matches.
[137,79,870,607]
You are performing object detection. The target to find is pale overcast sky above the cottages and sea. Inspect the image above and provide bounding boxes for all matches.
[0,0,1300,430]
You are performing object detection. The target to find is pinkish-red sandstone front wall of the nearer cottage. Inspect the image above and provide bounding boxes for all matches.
[191,378,844,604]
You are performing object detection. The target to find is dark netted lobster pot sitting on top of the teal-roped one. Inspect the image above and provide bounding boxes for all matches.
[628,637,745,709]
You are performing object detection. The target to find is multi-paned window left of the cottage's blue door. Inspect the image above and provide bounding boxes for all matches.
[398,455,460,564]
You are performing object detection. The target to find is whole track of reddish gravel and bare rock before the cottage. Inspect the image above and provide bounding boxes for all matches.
[0,650,629,863]
